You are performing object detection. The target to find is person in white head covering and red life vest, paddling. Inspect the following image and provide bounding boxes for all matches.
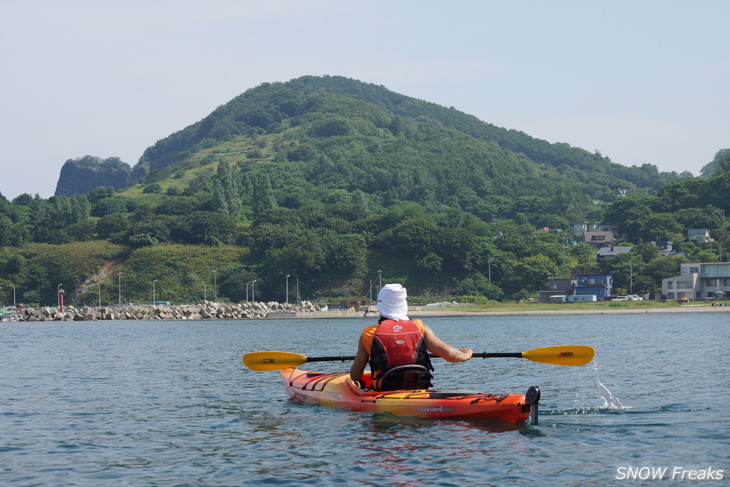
[350,284,473,390]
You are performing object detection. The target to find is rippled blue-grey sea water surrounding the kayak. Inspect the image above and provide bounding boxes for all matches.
[0,313,730,486]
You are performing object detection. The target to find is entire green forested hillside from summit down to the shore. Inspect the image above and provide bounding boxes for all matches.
[0,77,730,304]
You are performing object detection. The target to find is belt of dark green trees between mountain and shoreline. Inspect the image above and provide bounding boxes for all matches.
[0,151,730,304]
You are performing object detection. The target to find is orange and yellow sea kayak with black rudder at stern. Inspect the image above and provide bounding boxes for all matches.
[280,367,540,424]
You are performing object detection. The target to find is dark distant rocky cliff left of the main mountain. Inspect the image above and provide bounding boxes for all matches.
[55,156,140,196]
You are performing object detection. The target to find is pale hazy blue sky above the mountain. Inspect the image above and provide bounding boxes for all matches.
[0,0,730,199]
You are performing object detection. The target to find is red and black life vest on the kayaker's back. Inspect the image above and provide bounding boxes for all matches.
[362,319,433,384]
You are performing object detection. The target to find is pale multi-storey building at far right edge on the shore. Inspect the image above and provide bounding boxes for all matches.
[662,262,730,301]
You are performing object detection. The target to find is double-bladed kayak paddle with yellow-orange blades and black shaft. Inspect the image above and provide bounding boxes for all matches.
[243,345,595,370]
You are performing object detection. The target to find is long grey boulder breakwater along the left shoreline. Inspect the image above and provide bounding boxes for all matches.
[3,301,319,321]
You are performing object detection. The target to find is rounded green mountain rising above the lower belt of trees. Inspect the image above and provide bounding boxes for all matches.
[129,76,679,220]
